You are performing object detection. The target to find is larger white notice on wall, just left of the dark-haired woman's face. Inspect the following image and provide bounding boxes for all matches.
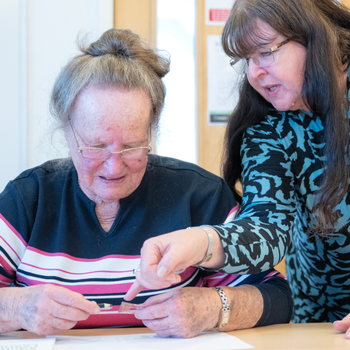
[207,35,240,125]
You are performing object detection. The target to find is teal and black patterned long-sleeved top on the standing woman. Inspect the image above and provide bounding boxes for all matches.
[214,71,350,322]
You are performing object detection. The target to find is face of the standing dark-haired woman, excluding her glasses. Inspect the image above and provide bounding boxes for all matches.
[247,20,307,111]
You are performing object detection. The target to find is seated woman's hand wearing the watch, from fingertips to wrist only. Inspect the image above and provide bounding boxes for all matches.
[135,287,221,338]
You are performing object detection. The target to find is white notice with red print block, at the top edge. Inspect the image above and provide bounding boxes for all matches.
[205,0,234,26]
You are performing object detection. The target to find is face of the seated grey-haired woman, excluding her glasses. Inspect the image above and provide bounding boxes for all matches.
[65,86,151,203]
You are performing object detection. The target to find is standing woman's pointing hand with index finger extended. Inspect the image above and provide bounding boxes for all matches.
[124,228,208,300]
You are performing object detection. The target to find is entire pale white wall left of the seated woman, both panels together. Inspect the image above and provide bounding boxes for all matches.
[0,0,113,191]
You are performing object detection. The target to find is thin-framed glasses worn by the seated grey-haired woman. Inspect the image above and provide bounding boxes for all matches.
[70,123,152,161]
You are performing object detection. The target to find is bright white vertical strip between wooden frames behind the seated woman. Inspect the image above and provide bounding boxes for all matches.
[157,0,197,163]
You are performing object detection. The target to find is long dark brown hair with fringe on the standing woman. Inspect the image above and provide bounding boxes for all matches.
[222,0,350,235]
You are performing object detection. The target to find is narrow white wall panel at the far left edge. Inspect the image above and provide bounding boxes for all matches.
[0,0,26,191]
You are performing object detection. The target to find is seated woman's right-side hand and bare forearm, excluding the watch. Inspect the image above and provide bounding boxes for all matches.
[135,285,264,338]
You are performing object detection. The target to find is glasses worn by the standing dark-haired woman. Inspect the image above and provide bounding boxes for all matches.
[230,39,290,74]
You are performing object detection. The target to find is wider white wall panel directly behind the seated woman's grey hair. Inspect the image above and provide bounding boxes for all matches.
[27,0,113,167]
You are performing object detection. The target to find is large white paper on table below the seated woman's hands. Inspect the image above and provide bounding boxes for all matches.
[50,332,253,350]
